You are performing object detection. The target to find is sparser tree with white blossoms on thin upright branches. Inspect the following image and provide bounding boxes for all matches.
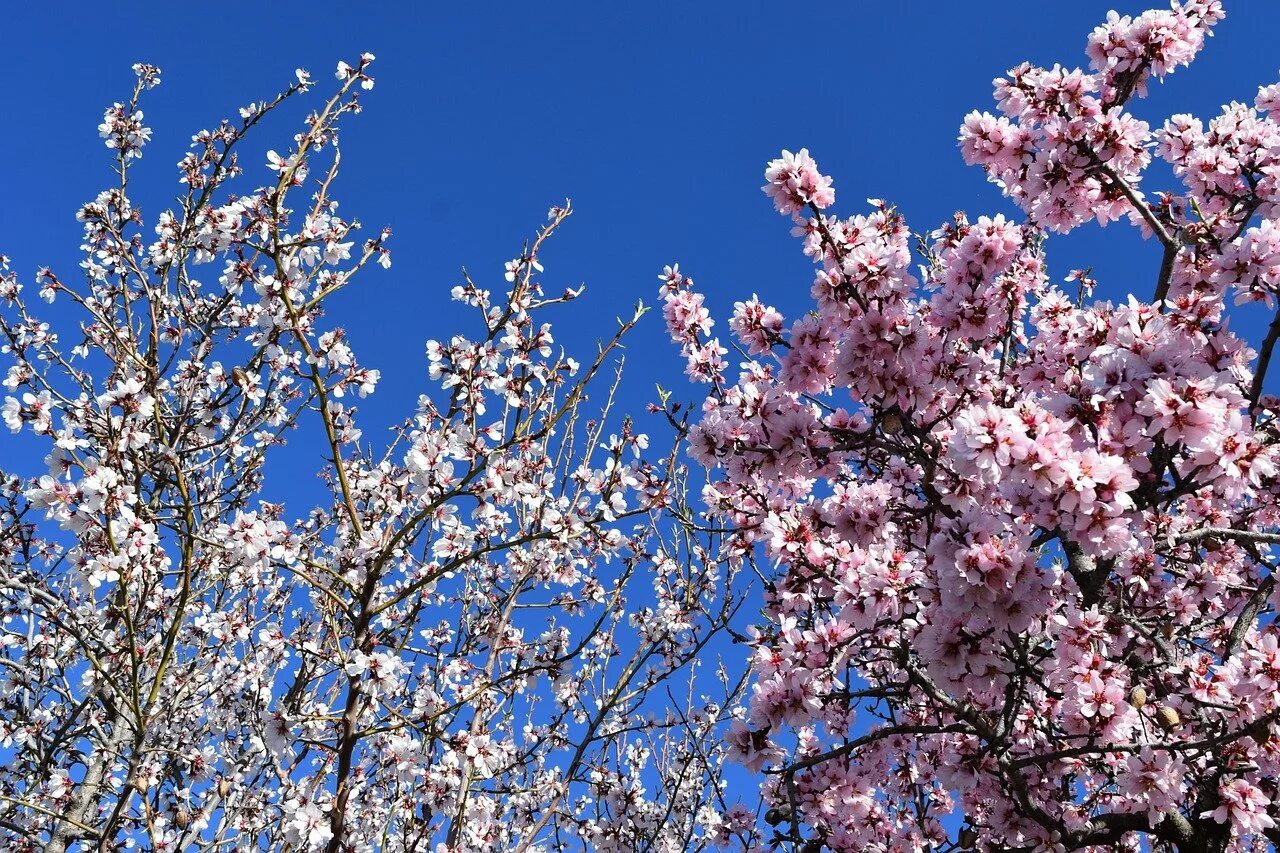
[0,55,750,853]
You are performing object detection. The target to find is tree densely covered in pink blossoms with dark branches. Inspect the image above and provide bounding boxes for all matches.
[662,0,1280,852]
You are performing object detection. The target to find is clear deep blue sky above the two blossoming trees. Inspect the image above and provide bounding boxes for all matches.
[0,0,1280,479]
